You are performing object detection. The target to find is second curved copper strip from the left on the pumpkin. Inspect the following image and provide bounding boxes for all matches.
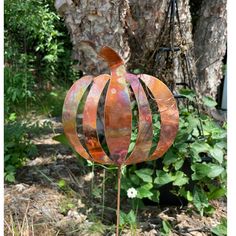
[83,75,113,164]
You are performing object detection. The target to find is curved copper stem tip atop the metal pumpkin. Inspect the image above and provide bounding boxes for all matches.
[98,46,124,69]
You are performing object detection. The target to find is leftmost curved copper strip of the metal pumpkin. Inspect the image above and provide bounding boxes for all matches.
[62,76,93,161]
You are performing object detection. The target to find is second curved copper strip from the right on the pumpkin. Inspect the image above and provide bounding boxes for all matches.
[125,74,153,165]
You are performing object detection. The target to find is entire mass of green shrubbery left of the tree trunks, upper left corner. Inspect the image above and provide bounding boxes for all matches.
[4,0,79,116]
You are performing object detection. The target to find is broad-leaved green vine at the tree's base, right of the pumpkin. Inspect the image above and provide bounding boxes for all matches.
[121,102,226,215]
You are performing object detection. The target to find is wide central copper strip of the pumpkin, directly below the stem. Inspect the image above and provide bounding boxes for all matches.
[105,65,132,165]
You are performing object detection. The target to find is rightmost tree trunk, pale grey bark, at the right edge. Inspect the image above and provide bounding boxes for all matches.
[194,0,226,98]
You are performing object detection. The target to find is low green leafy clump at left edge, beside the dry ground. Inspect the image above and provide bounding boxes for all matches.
[4,121,37,182]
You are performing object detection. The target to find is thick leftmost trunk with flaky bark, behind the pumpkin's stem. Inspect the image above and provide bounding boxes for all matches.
[55,0,130,75]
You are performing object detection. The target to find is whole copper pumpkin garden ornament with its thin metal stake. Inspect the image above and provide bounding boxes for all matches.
[62,43,179,236]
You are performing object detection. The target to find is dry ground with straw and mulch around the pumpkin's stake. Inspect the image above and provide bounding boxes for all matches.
[4,119,227,236]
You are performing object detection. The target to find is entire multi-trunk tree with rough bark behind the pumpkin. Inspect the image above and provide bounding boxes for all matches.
[55,0,226,99]
